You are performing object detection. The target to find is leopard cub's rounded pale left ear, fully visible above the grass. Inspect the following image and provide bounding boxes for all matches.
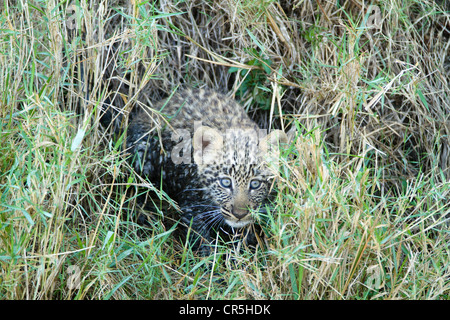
[192,126,223,165]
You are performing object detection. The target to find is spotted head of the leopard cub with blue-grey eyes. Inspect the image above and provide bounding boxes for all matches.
[193,126,287,228]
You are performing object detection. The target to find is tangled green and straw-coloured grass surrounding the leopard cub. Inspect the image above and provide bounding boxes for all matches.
[0,0,450,299]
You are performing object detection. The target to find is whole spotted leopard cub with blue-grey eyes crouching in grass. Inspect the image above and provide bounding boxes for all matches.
[127,89,279,250]
